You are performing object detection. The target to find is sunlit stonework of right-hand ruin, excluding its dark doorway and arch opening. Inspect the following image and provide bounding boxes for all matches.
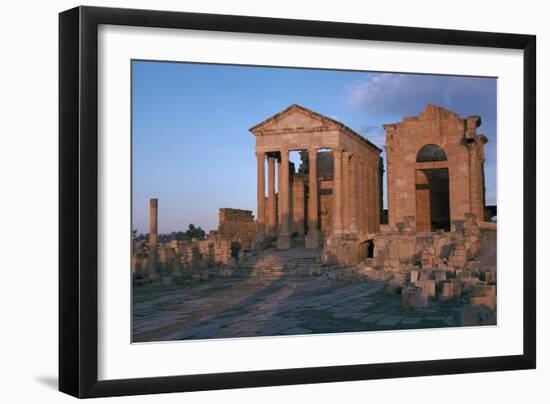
[384,105,487,225]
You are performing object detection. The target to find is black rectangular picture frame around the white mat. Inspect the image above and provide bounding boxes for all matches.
[59,7,536,398]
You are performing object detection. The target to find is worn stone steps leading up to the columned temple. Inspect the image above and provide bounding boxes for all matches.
[235,248,325,279]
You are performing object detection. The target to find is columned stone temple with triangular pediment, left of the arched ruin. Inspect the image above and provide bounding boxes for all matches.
[250,104,382,256]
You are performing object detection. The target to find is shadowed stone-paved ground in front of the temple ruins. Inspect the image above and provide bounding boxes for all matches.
[133,276,472,342]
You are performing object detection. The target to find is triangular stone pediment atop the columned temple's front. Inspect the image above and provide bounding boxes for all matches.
[250,104,343,134]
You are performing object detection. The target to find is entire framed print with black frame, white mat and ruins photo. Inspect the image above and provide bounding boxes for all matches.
[59,7,536,397]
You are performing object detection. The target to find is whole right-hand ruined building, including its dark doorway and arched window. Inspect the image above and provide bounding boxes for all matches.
[384,104,487,232]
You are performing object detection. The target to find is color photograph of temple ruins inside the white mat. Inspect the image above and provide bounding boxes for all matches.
[128,59,498,343]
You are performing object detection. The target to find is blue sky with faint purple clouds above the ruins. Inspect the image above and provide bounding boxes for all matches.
[132,61,497,233]
